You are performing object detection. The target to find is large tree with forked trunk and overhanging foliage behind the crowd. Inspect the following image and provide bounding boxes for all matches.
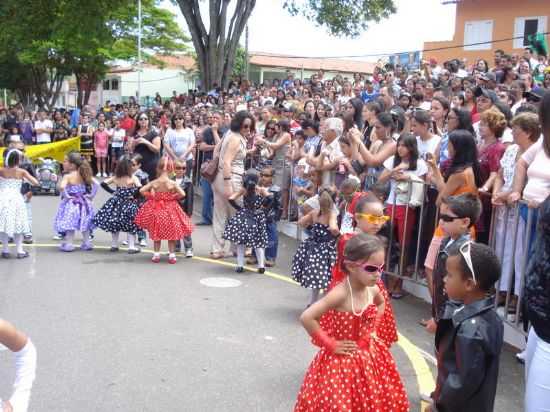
[177,0,395,89]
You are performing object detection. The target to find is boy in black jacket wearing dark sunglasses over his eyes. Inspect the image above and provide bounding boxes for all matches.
[426,193,481,333]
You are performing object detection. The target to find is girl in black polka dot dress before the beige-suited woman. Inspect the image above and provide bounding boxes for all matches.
[223,170,270,273]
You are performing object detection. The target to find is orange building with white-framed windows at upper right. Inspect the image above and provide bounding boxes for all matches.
[424,0,550,64]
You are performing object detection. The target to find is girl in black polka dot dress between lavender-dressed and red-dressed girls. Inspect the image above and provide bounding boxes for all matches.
[93,158,141,255]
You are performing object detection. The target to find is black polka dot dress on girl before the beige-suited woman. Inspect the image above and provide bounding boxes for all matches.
[223,195,267,248]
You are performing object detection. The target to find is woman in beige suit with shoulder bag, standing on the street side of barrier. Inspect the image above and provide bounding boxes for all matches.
[210,110,255,259]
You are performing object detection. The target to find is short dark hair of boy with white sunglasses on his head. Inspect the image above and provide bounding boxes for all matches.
[449,242,502,292]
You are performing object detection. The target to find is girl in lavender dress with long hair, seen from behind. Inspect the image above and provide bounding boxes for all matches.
[54,151,98,252]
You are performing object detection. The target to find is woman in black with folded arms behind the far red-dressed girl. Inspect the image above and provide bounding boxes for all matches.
[130,113,162,180]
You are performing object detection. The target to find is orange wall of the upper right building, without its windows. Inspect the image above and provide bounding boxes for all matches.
[423,0,550,65]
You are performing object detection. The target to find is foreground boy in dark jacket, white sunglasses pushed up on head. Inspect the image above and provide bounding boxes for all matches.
[427,241,503,412]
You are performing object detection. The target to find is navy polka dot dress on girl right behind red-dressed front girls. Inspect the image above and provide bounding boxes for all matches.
[292,223,336,289]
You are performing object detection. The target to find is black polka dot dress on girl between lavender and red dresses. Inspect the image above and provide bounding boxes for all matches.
[93,187,139,234]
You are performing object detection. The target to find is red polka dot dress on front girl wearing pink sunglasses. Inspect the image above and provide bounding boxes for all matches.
[294,305,409,412]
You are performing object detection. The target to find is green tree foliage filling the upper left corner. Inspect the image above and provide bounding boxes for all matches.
[0,0,189,105]
